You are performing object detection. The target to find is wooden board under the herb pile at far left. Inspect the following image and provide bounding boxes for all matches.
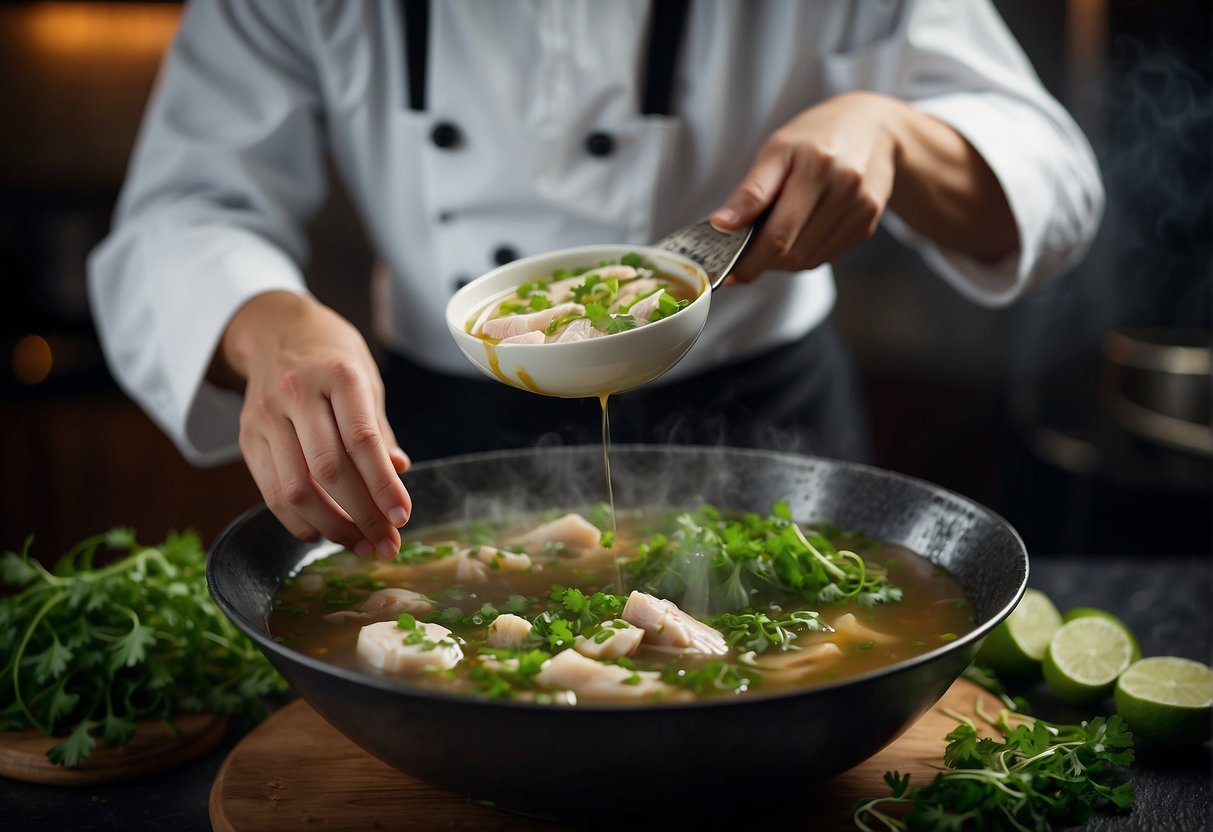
[0,713,227,786]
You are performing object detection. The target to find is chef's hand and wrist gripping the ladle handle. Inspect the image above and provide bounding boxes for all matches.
[712,92,1019,283]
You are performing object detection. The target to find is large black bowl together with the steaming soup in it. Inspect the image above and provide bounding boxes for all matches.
[207,446,1027,819]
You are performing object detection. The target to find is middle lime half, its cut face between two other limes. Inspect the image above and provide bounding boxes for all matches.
[1041,616,1133,705]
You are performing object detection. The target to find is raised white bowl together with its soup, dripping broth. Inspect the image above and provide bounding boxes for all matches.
[446,244,712,398]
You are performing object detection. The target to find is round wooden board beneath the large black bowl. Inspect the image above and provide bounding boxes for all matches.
[210,679,1000,832]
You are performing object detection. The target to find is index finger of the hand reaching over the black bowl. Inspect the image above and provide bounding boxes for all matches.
[330,378,412,528]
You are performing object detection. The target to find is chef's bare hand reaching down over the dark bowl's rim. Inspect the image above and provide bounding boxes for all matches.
[210,291,412,555]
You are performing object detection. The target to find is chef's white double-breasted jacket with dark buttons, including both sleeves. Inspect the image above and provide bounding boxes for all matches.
[89,0,1103,463]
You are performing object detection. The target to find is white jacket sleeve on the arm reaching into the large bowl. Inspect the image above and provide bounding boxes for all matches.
[89,0,326,465]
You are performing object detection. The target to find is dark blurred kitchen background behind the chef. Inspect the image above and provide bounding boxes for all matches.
[0,0,1213,559]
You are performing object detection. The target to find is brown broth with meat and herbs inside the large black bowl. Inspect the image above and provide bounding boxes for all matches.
[270,502,973,705]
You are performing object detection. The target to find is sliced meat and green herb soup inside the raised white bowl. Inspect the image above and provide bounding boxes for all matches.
[468,252,696,343]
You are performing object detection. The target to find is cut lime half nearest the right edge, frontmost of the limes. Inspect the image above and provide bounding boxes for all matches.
[1115,656,1213,745]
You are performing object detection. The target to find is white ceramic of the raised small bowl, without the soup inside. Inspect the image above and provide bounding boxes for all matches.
[446,243,712,399]
